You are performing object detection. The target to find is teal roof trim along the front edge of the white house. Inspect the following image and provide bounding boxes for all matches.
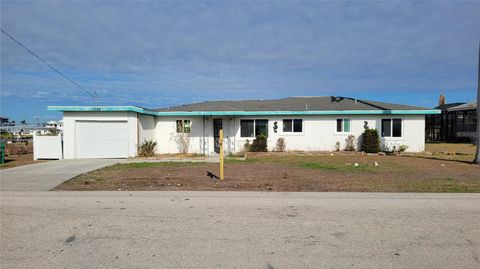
[47,106,441,114]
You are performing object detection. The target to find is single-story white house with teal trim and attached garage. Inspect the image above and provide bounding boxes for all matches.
[48,96,440,159]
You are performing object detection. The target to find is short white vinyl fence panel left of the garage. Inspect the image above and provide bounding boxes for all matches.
[33,134,63,160]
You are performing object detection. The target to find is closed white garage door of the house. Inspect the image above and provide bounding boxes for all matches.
[75,121,128,158]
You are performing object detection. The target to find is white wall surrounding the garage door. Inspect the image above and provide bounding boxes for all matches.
[63,111,138,159]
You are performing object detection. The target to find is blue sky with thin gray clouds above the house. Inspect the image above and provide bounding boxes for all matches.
[0,1,480,123]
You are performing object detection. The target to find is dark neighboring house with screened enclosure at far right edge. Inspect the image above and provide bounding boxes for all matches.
[425,102,477,142]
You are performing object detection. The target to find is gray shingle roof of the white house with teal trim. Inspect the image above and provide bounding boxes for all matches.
[156,96,428,111]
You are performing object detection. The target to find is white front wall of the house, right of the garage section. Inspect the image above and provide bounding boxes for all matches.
[156,115,425,154]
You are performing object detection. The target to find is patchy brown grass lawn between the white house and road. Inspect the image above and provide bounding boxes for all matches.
[56,153,480,192]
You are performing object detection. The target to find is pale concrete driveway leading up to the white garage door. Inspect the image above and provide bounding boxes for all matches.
[0,159,124,191]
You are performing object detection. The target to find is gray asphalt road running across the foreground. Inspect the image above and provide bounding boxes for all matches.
[1,192,480,268]
